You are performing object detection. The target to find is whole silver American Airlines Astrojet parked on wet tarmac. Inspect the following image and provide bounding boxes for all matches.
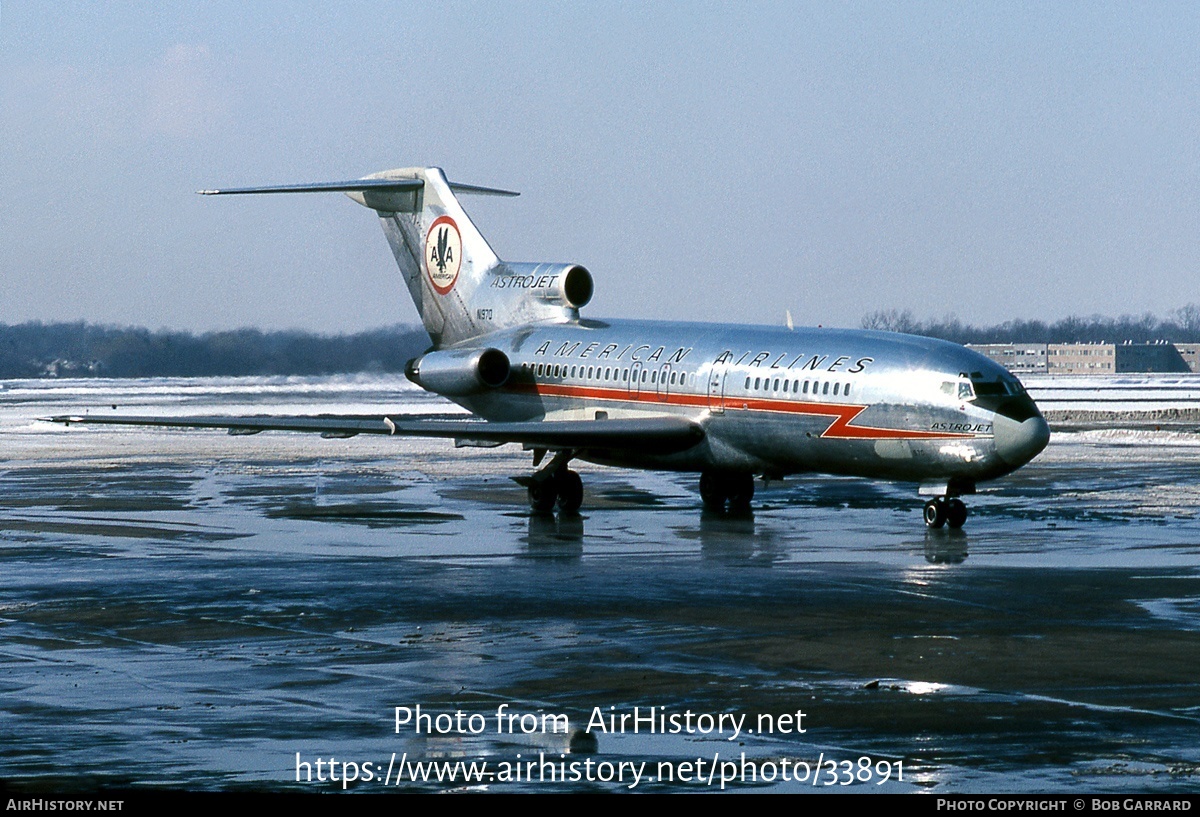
[50,168,1050,529]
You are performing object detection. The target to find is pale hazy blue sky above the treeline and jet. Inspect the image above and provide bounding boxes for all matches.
[0,0,1200,332]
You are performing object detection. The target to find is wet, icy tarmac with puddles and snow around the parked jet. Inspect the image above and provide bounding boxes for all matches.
[0,377,1200,793]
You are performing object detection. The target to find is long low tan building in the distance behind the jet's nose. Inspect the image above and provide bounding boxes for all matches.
[968,341,1200,374]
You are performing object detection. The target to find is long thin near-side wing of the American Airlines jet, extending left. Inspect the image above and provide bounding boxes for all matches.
[46,414,704,453]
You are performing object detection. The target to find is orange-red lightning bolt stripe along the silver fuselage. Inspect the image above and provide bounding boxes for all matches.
[505,383,980,440]
